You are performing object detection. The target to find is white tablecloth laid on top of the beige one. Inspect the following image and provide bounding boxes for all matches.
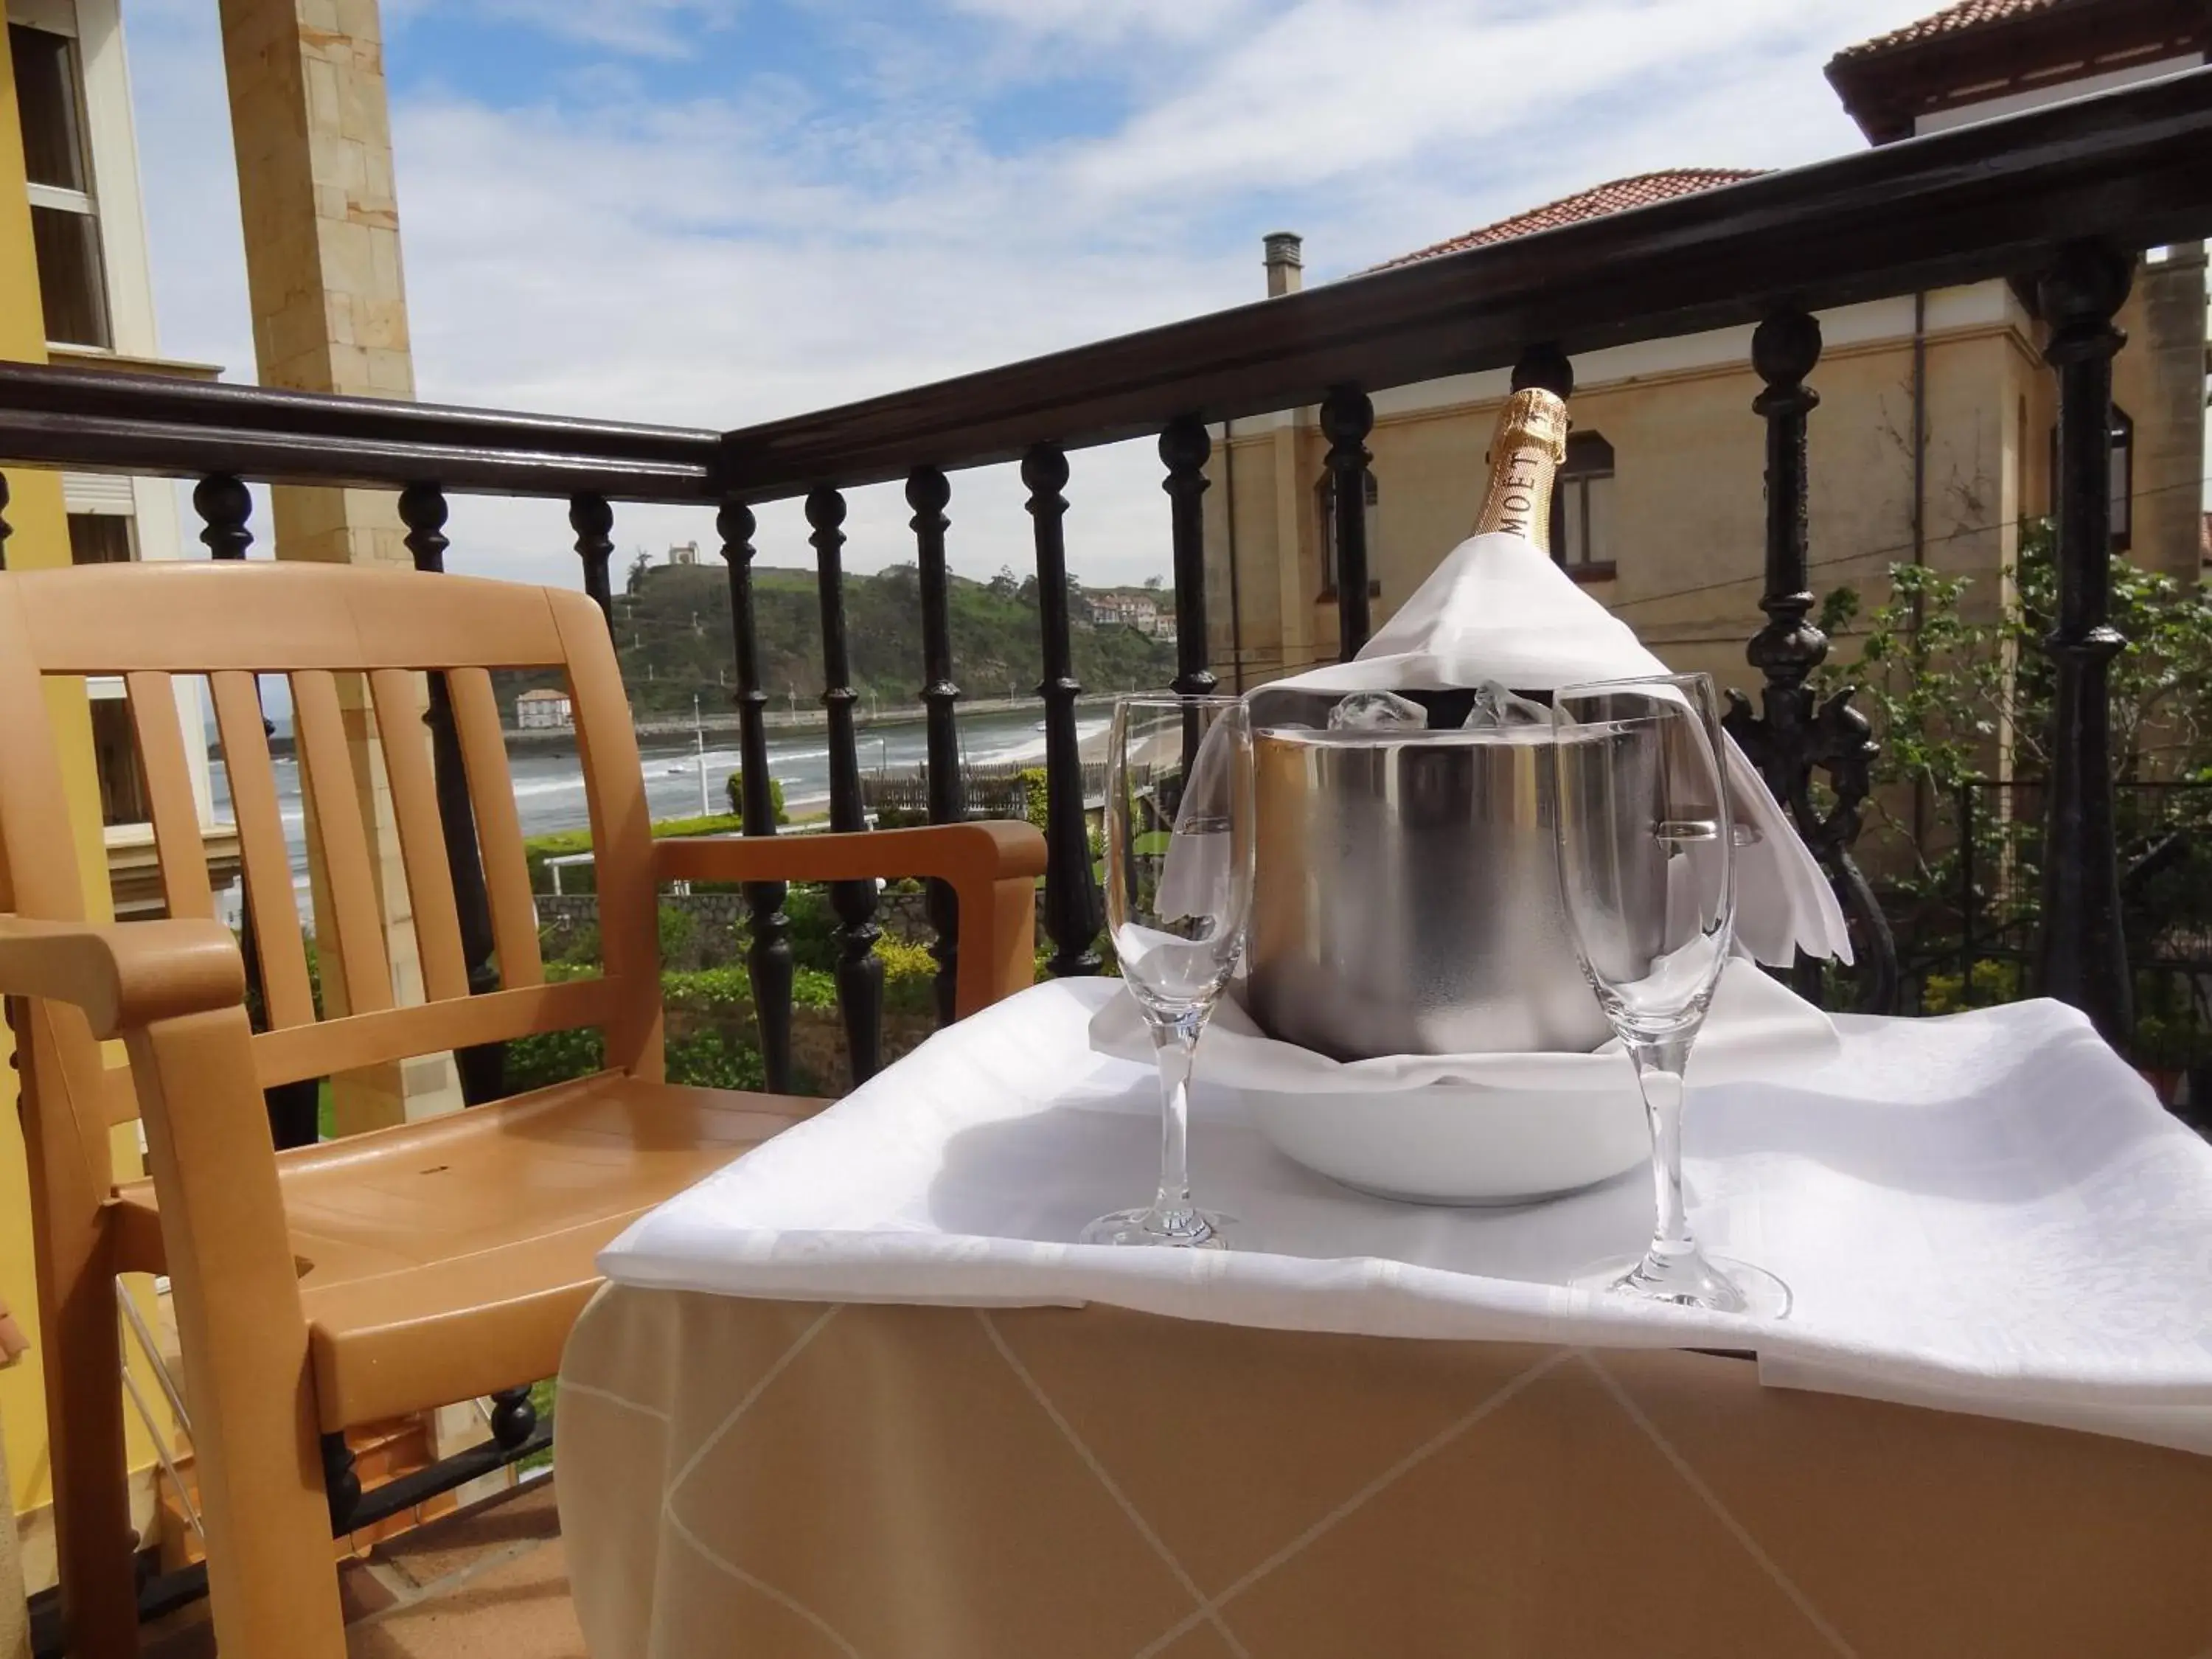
[602,980,2212,1451]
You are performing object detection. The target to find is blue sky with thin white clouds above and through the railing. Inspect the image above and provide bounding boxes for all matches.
[124,0,1935,582]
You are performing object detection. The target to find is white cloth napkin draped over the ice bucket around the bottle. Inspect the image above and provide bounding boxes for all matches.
[1245,533,1851,967]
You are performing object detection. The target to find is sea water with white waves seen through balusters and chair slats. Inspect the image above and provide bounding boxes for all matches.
[212,708,1106,922]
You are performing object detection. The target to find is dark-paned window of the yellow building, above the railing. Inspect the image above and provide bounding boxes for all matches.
[7,22,113,349]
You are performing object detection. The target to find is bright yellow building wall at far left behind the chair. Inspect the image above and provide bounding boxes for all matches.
[0,35,166,1531]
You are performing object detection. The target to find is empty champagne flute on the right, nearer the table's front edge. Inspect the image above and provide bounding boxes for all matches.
[1551,675,1790,1318]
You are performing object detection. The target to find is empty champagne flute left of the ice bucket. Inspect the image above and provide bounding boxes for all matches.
[1082,695,1252,1250]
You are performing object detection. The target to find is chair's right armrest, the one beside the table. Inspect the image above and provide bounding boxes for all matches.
[653,818,1044,1020]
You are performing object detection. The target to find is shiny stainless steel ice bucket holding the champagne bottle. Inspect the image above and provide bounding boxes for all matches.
[1250,726,1648,1060]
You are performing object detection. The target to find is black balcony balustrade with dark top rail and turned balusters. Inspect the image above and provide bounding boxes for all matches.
[0,69,2212,1053]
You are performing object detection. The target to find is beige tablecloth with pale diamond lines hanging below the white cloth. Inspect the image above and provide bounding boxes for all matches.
[557,1287,2212,1659]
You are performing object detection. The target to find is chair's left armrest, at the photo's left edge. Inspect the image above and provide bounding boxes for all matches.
[0,916,246,1037]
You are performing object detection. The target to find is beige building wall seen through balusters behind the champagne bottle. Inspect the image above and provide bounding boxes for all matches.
[1208,290,2203,708]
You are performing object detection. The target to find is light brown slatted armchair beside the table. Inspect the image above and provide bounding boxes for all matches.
[0,564,1044,1659]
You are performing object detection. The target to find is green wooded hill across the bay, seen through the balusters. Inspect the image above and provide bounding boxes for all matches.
[584,562,1175,714]
